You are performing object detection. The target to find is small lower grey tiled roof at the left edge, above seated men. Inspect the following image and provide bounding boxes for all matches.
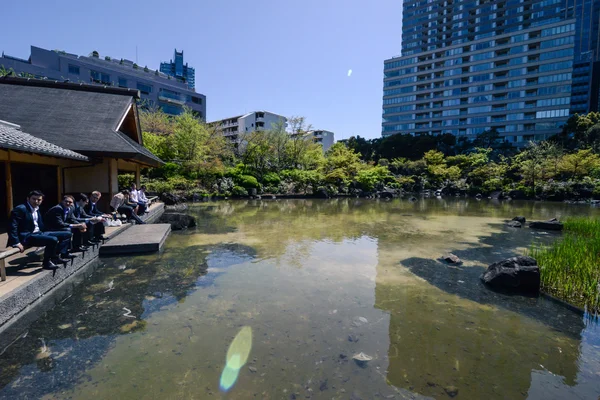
[0,121,88,161]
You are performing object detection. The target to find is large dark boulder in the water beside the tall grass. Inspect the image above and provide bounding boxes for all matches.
[481,256,540,294]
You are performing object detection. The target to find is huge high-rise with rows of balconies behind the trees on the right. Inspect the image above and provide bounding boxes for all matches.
[382,0,576,145]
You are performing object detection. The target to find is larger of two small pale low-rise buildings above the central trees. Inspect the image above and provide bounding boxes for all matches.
[211,111,287,143]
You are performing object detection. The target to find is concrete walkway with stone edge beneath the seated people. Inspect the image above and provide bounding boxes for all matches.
[0,203,164,332]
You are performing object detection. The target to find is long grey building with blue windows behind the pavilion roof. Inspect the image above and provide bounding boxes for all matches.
[0,46,206,119]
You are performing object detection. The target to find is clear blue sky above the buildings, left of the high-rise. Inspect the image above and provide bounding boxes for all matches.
[0,0,402,139]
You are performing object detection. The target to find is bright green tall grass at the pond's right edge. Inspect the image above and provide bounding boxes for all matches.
[530,218,600,313]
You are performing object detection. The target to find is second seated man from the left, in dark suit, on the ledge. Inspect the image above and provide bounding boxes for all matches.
[44,194,88,252]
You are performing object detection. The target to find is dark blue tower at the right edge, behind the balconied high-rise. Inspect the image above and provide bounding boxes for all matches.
[569,0,600,114]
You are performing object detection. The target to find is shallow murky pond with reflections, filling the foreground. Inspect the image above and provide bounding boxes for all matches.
[0,199,600,399]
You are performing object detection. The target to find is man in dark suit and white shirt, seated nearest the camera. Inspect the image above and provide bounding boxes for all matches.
[7,190,74,270]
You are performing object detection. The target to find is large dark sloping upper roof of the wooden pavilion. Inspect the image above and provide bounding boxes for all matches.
[0,77,163,166]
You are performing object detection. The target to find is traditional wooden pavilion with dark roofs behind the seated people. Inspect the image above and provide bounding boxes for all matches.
[0,77,163,225]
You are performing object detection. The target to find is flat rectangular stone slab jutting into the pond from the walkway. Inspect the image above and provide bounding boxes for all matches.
[100,224,171,256]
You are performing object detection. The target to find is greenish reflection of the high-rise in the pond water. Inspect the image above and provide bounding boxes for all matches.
[375,241,583,399]
